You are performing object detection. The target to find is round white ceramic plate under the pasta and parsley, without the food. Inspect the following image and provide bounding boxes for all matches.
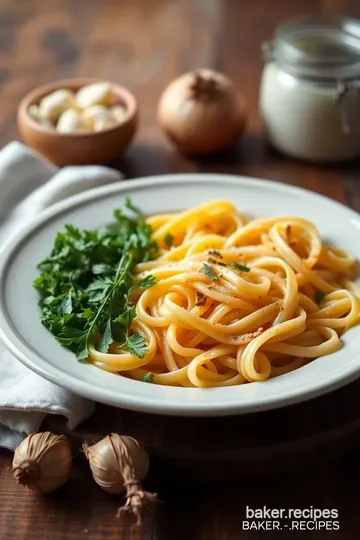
[0,174,360,416]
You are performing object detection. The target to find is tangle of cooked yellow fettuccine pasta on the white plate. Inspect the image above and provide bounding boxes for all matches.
[91,200,360,388]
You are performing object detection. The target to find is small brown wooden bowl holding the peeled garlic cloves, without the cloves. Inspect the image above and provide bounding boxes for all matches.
[17,78,138,166]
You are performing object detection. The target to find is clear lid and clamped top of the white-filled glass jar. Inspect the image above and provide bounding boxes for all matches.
[265,17,360,80]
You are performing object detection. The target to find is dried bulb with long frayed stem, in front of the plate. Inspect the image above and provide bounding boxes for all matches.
[83,433,156,524]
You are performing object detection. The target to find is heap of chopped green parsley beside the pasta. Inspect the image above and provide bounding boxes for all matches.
[34,200,157,360]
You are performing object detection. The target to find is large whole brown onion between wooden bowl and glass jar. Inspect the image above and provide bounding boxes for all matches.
[157,69,246,154]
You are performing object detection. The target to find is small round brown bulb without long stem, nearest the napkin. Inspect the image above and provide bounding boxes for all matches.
[12,431,72,493]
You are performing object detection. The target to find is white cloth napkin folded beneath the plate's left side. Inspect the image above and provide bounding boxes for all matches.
[0,141,123,450]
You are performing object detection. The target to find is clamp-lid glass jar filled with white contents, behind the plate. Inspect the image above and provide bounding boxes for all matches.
[260,17,360,163]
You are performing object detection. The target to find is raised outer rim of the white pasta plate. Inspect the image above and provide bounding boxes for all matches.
[0,173,360,417]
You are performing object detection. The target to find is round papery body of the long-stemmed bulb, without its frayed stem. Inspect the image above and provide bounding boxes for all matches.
[84,433,149,494]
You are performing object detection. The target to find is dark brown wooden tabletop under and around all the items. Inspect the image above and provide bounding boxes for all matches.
[0,0,360,540]
